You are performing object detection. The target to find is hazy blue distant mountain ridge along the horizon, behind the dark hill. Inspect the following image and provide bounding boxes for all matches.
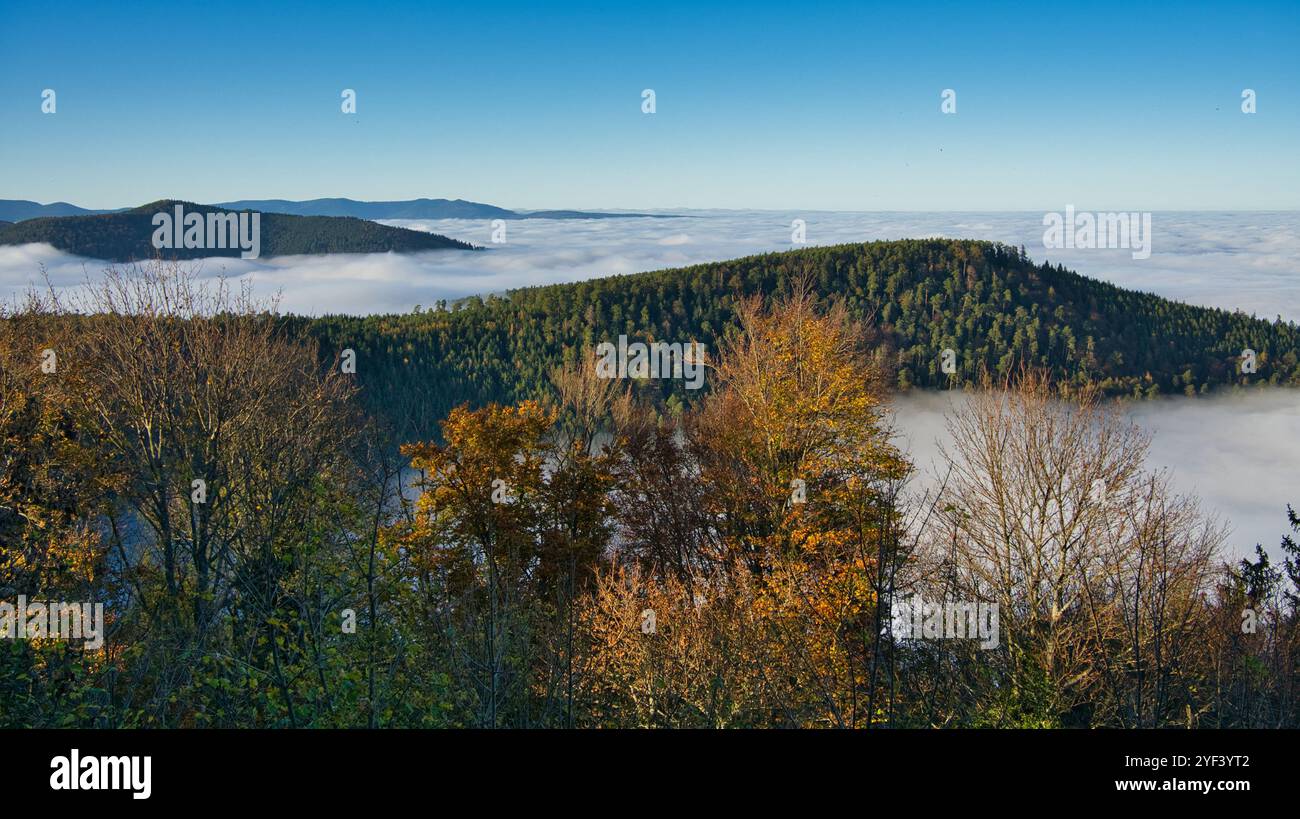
[0,198,676,222]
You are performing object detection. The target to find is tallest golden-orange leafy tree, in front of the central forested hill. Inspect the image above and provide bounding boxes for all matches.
[574,282,909,725]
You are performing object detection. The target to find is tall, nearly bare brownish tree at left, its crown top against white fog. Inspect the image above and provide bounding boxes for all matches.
[52,263,354,724]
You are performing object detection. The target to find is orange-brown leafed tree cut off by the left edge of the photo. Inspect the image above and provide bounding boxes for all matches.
[0,295,108,727]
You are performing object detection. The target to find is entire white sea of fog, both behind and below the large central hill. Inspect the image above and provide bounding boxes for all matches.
[0,207,1300,554]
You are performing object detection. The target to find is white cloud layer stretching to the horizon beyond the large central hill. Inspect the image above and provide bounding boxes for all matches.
[0,211,1300,320]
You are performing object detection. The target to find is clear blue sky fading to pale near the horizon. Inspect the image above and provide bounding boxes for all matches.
[0,0,1300,211]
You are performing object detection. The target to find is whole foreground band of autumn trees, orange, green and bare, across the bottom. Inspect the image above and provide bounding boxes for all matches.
[0,262,1300,729]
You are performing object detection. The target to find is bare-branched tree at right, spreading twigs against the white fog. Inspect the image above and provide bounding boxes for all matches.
[933,371,1222,725]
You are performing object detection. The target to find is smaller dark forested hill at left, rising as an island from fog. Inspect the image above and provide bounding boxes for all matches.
[0,200,472,261]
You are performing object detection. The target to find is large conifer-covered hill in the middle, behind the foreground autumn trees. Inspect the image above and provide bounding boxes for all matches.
[304,239,1300,436]
